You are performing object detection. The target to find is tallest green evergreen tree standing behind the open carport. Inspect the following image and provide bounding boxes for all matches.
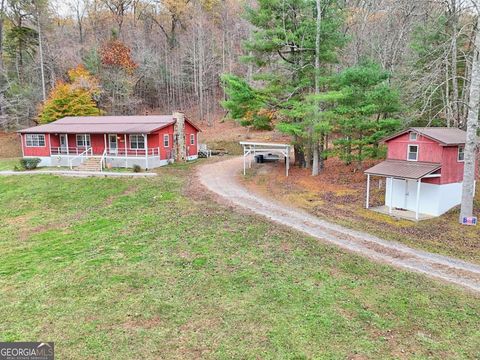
[224,0,345,170]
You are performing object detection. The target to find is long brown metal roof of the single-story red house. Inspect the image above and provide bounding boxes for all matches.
[18,115,176,134]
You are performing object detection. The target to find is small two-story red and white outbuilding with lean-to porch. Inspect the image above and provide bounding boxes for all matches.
[365,128,478,220]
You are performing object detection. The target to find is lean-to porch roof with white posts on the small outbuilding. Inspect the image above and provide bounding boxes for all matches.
[365,160,442,220]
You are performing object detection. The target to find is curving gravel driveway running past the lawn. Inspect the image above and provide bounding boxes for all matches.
[198,157,480,293]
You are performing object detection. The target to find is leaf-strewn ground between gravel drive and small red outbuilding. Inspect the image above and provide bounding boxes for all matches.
[244,159,480,263]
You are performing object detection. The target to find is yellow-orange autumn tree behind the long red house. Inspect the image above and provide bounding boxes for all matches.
[38,65,101,124]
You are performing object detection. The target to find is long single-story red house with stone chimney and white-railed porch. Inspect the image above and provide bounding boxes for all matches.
[18,113,200,170]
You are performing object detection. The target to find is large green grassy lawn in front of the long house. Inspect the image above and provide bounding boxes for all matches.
[0,162,480,359]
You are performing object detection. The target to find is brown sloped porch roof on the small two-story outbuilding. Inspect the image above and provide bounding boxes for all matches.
[365,160,442,180]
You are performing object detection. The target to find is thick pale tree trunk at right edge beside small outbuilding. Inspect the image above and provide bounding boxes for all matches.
[459,16,480,222]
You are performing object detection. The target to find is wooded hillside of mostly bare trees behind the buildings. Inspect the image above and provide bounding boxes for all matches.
[0,0,475,133]
